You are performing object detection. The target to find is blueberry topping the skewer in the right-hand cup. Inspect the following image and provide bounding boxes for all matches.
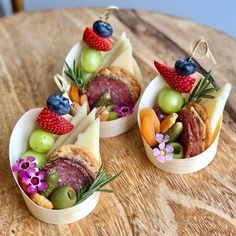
[175,58,197,75]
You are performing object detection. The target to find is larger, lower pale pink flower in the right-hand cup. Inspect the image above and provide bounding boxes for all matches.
[152,142,174,163]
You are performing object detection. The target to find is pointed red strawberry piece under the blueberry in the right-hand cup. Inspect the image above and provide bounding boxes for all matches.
[154,61,196,93]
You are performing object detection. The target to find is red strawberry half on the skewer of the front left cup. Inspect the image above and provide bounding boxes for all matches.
[36,107,74,135]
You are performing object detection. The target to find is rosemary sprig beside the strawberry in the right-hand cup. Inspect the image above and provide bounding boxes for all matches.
[188,70,216,102]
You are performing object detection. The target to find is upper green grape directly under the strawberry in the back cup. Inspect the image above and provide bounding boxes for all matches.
[80,47,102,73]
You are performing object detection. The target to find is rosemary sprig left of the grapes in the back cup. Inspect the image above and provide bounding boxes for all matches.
[65,60,86,93]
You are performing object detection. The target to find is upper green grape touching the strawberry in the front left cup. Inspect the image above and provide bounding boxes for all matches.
[29,129,55,153]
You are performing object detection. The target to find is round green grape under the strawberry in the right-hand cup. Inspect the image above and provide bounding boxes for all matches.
[155,87,184,114]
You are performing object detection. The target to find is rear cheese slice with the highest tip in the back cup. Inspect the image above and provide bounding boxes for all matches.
[99,33,131,70]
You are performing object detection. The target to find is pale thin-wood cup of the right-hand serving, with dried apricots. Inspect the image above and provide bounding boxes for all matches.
[138,76,222,174]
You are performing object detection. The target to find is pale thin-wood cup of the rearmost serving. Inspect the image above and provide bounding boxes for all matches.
[62,42,143,138]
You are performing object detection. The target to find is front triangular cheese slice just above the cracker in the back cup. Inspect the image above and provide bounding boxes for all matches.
[111,45,134,73]
